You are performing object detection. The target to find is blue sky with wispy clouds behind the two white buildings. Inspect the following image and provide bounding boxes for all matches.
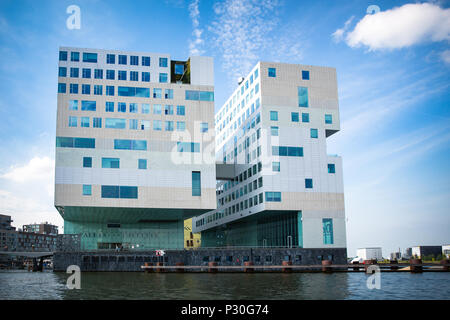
[0,0,450,256]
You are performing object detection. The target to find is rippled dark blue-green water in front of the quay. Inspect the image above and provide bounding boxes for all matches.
[0,271,450,300]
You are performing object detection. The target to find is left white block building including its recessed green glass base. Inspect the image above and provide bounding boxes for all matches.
[55,47,216,250]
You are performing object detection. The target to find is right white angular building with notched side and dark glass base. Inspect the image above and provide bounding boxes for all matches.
[193,62,346,252]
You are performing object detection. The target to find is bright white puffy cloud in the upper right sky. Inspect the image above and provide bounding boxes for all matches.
[333,3,450,51]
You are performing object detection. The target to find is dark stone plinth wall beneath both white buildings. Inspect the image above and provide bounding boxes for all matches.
[53,248,347,272]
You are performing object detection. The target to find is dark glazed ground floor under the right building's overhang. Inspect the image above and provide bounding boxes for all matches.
[201,211,303,248]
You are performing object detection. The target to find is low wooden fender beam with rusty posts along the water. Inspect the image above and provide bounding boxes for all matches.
[141,260,450,273]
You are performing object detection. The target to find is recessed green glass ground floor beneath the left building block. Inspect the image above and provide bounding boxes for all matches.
[58,207,208,251]
